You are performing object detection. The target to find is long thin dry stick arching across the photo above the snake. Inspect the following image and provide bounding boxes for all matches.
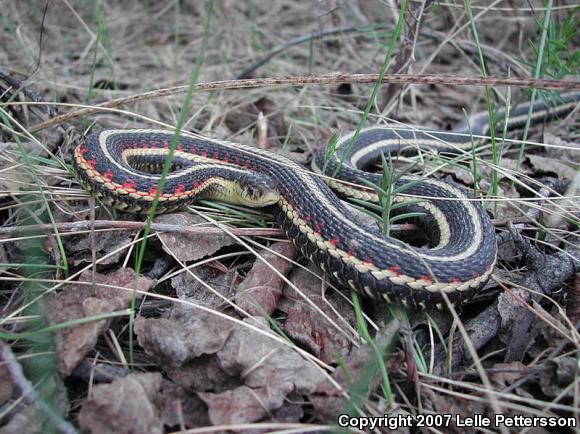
[30,74,580,133]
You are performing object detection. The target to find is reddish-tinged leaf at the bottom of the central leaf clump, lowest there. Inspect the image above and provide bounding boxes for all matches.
[198,382,293,425]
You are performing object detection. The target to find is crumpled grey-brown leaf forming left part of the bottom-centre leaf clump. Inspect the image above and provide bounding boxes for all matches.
[135,303,234,367]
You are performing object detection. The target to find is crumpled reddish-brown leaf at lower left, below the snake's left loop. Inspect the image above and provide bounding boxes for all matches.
[46,268,155,376]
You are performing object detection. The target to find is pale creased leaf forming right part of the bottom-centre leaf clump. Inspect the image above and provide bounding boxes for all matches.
[217,317,325,393]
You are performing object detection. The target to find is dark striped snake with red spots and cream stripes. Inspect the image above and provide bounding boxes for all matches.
[72,93,580,309]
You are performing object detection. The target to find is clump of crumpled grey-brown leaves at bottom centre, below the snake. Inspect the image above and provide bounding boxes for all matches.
[135,306,325,424]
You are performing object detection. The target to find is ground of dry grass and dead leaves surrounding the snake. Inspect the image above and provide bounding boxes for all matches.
[0,0,580,433]
